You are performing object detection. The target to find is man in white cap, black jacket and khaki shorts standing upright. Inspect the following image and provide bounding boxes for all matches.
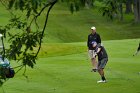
[87,26,101,72]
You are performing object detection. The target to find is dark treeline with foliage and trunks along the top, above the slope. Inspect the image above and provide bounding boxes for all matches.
[64,0,140,23]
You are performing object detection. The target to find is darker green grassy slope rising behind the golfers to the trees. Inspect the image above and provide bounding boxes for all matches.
[44,3,140,42]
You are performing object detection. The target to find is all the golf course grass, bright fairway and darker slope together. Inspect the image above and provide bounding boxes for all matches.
[0,3,140,93]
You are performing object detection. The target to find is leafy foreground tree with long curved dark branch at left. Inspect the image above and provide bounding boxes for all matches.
[0,0,58,85]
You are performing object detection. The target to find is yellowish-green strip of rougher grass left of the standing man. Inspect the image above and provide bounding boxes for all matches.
[39,42,87,57]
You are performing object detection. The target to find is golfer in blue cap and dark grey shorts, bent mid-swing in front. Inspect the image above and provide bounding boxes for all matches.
[92,41,108,83]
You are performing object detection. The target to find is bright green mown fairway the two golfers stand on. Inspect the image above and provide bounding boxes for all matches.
[0,39,140,93]
